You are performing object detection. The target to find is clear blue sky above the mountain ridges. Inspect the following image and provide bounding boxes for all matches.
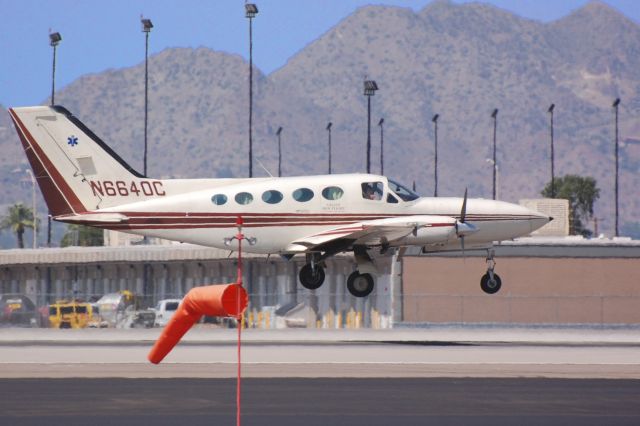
[0,0,640,107]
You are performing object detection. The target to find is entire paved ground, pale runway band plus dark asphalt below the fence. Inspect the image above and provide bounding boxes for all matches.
[0,327,640,426]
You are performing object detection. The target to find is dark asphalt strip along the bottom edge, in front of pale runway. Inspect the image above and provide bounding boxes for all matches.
[0,378,640,426]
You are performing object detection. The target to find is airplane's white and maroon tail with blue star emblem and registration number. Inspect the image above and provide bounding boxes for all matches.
[9,106,154,217]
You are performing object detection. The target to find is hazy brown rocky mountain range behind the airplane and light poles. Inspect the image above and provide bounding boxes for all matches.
[0,1,640,243]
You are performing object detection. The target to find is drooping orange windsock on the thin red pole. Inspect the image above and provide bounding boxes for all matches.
[147,284,248,364]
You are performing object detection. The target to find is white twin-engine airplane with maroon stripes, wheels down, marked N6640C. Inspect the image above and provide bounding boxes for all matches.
[9,106,552,297]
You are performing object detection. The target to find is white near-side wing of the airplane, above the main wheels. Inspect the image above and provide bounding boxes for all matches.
[286,215,455,253]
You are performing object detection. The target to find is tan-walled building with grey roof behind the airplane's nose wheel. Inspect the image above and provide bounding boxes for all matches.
[402,238,640,324]
